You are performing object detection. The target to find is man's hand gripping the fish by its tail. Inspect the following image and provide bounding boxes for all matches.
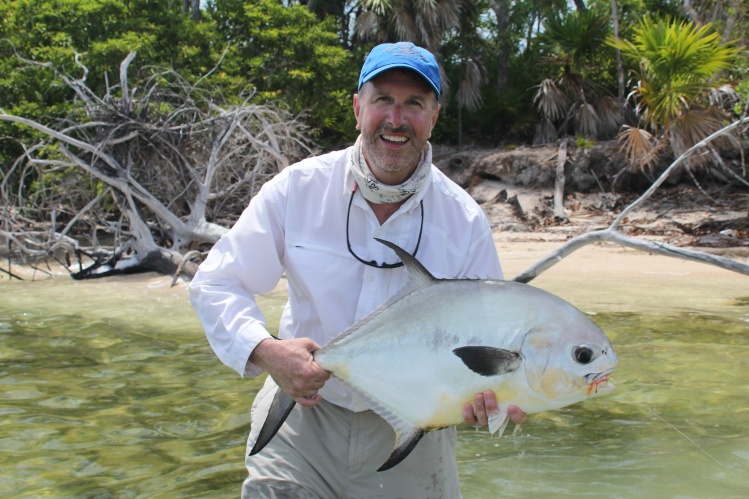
[250,338,330,407]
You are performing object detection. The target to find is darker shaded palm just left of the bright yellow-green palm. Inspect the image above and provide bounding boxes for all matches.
[534,10,620,143]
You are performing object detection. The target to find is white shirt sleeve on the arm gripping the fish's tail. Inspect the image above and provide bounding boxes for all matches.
[189,178,284,376]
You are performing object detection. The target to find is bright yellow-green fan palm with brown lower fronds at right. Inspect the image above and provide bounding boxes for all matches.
[609,17,737,169]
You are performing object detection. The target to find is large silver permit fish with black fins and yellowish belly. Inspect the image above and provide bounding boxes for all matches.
[250,239,616,471]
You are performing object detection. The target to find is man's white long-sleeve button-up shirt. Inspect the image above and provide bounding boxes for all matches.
[190,149,502,410]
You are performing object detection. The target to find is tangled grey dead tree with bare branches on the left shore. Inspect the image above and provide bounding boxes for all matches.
[0,52,313,279]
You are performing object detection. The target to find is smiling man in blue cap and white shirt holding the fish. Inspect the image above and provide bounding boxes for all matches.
[190,42,524,498]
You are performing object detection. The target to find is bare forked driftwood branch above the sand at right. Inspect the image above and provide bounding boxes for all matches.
[513,118,749,283]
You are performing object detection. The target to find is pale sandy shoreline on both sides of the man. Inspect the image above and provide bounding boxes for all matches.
[5,236,749,314]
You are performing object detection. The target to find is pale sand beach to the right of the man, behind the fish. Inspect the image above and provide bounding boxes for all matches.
[495,233,749,311]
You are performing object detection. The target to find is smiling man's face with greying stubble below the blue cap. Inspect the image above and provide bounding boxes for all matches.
[354,70,440,184]
